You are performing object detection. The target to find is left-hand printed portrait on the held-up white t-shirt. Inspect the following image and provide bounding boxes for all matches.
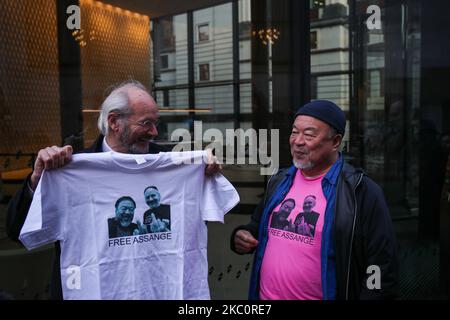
[108,196,139,239]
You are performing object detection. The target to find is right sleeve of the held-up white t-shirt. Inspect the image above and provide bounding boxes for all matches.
[201,174,240,223]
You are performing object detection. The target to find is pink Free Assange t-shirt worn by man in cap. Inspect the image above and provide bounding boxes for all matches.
[260,170,327,300]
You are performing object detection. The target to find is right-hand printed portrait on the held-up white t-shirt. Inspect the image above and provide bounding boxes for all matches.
[143,186,170,233]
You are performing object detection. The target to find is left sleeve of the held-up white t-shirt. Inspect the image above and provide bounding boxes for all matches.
[19,171,67,250]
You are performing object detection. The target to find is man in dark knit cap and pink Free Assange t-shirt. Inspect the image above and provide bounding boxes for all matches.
[231,100,398,300]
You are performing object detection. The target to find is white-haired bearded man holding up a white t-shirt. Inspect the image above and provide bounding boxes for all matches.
[7,80,220,299]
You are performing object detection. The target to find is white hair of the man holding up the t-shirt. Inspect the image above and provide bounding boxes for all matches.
[97,80,150,136]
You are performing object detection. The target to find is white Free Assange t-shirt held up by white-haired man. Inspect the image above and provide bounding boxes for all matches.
[20,151,239,299]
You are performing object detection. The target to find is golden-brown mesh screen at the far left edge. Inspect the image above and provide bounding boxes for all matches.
[0,0,61,172]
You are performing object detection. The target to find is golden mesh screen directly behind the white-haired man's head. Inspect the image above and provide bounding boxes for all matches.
[79,0,151,146]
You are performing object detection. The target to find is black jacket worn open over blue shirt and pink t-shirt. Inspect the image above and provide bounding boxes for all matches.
[234,162,398,300]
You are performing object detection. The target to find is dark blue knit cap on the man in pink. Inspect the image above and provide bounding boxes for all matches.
[294,100,345,135]
